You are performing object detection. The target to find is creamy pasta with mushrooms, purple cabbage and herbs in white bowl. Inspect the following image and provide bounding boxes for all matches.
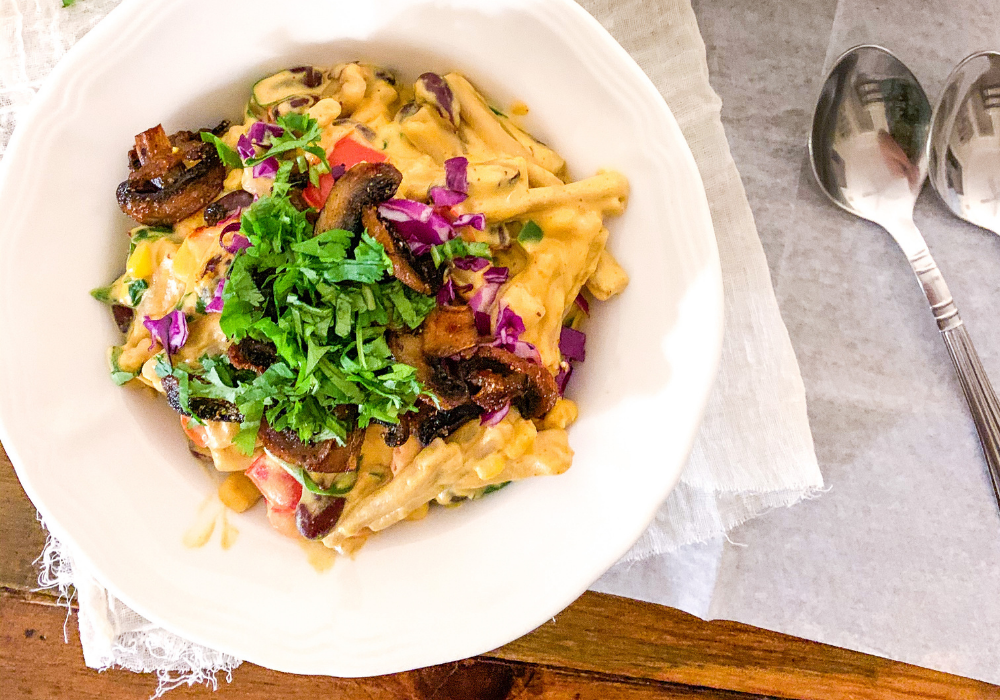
[93,63,628,553]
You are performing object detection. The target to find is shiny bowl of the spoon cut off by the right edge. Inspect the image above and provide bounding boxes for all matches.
[930,51,1000,234]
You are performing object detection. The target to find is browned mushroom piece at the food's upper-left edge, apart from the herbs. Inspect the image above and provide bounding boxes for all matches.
[117,124,226,226]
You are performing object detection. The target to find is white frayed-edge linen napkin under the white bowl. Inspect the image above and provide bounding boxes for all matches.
[0,0,823,696]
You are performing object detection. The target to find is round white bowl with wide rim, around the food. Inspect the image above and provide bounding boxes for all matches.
[0,0,722,676]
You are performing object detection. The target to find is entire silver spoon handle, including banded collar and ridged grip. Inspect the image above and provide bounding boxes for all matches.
[908,247,1000,506]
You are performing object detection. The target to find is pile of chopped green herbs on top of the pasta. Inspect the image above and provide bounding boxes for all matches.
[157,114,435,454]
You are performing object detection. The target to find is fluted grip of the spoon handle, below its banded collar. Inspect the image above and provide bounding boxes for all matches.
[941,322,1000,505]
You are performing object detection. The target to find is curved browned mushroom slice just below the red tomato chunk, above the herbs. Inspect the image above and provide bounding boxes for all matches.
[316,163,403,233]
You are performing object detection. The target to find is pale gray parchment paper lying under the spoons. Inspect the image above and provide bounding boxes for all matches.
[597,0,1000,683]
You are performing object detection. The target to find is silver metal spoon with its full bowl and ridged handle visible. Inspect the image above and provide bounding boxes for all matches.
[809,46,1000,505]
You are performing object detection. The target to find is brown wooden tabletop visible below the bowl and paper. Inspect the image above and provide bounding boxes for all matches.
[0,448,1000,700]
